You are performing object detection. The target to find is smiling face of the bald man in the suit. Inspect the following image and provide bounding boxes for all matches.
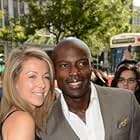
[54,43,91,99]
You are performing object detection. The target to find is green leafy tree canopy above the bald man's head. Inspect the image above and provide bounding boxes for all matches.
[0,0,132,55]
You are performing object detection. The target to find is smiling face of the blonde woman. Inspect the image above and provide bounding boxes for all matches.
[16,57,50,109]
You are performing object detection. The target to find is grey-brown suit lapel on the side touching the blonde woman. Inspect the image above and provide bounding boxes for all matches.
[47,99,80,140]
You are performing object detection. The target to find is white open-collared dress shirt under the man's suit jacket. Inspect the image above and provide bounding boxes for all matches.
[61,83,105,140]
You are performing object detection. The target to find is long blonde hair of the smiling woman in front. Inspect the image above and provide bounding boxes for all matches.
[0,47,55,132]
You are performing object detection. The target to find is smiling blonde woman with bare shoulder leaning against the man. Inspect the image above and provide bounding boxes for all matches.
[0,48,55,140]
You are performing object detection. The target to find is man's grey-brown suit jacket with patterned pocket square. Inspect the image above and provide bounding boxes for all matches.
[42,86,140,140]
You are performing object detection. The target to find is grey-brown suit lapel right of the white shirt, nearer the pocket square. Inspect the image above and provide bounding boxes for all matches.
[95,86,112,140]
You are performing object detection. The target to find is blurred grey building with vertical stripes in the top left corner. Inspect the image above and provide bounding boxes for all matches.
[0,0,28,27]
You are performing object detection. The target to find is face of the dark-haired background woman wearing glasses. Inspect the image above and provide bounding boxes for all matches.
[117,70,138,93]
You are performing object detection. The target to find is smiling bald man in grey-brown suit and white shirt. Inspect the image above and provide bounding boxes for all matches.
[42,37,140,140]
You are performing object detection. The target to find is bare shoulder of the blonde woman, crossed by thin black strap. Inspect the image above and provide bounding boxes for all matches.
[2,111,35,140]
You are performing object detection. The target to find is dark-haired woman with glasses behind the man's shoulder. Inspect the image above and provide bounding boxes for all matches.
[111,64,140,103]
